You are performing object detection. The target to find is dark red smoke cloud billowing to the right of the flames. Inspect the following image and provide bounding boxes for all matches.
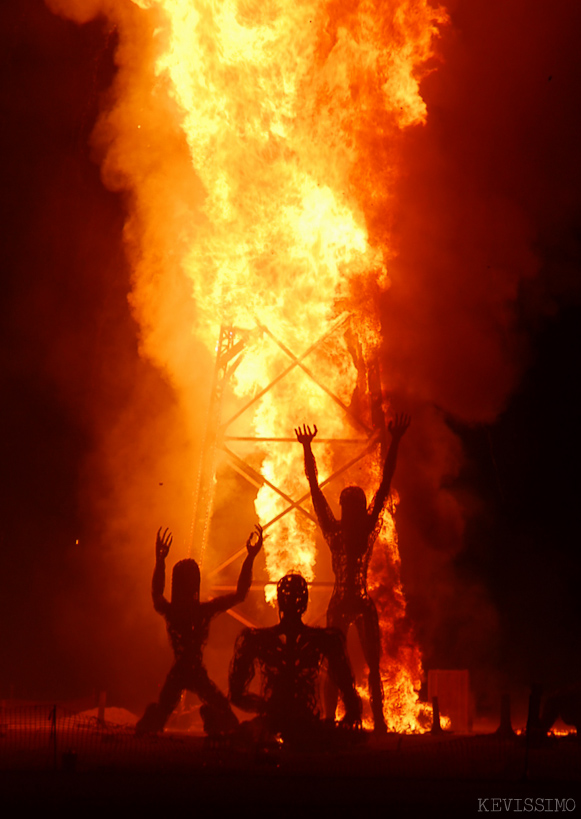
[372,2,580,692]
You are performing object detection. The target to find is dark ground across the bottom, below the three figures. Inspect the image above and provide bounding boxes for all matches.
[0,734,581,816]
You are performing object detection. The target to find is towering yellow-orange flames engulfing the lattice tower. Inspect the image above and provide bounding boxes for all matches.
[51,0,446,731]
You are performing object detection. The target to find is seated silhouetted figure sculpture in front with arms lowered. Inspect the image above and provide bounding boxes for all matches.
[230,574,361,744]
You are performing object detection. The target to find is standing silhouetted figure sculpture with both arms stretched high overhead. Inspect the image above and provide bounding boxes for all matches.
[295,415,410,732]
